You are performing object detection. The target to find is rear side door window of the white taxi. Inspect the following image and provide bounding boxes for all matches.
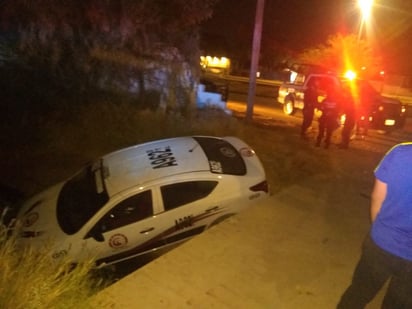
[161,181,217,210]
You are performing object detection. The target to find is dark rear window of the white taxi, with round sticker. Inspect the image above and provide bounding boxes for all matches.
[194,136,246,175]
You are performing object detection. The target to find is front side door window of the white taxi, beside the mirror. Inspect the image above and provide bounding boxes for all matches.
[98,190,153,233]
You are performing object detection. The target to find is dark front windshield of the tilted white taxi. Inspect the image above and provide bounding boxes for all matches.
[57,160,109,235]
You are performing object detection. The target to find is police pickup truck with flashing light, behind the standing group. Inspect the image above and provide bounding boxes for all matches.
[278,73,406,132]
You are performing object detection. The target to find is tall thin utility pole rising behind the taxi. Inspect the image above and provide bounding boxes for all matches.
[246,0,265,122]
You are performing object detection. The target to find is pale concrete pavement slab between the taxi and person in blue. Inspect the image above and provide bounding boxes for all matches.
[91,186,381,309]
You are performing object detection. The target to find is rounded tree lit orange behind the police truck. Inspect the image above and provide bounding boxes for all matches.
[298,34,381,77]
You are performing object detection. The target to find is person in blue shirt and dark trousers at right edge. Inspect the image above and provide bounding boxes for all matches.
[337,143,412,309]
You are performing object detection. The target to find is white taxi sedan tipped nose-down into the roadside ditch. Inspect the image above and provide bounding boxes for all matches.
[9,136,268,267]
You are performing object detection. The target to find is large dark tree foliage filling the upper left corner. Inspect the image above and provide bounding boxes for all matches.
[0,0,216,111]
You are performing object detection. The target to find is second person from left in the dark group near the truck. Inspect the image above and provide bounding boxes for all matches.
[316,86,339,149]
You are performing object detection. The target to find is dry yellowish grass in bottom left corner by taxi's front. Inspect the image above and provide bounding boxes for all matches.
[0,225,106,309]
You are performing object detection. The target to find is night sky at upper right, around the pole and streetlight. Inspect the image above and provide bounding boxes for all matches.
[201,0,412,74]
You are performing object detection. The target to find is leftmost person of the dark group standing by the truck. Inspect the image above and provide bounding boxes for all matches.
[300,79,318,139]
